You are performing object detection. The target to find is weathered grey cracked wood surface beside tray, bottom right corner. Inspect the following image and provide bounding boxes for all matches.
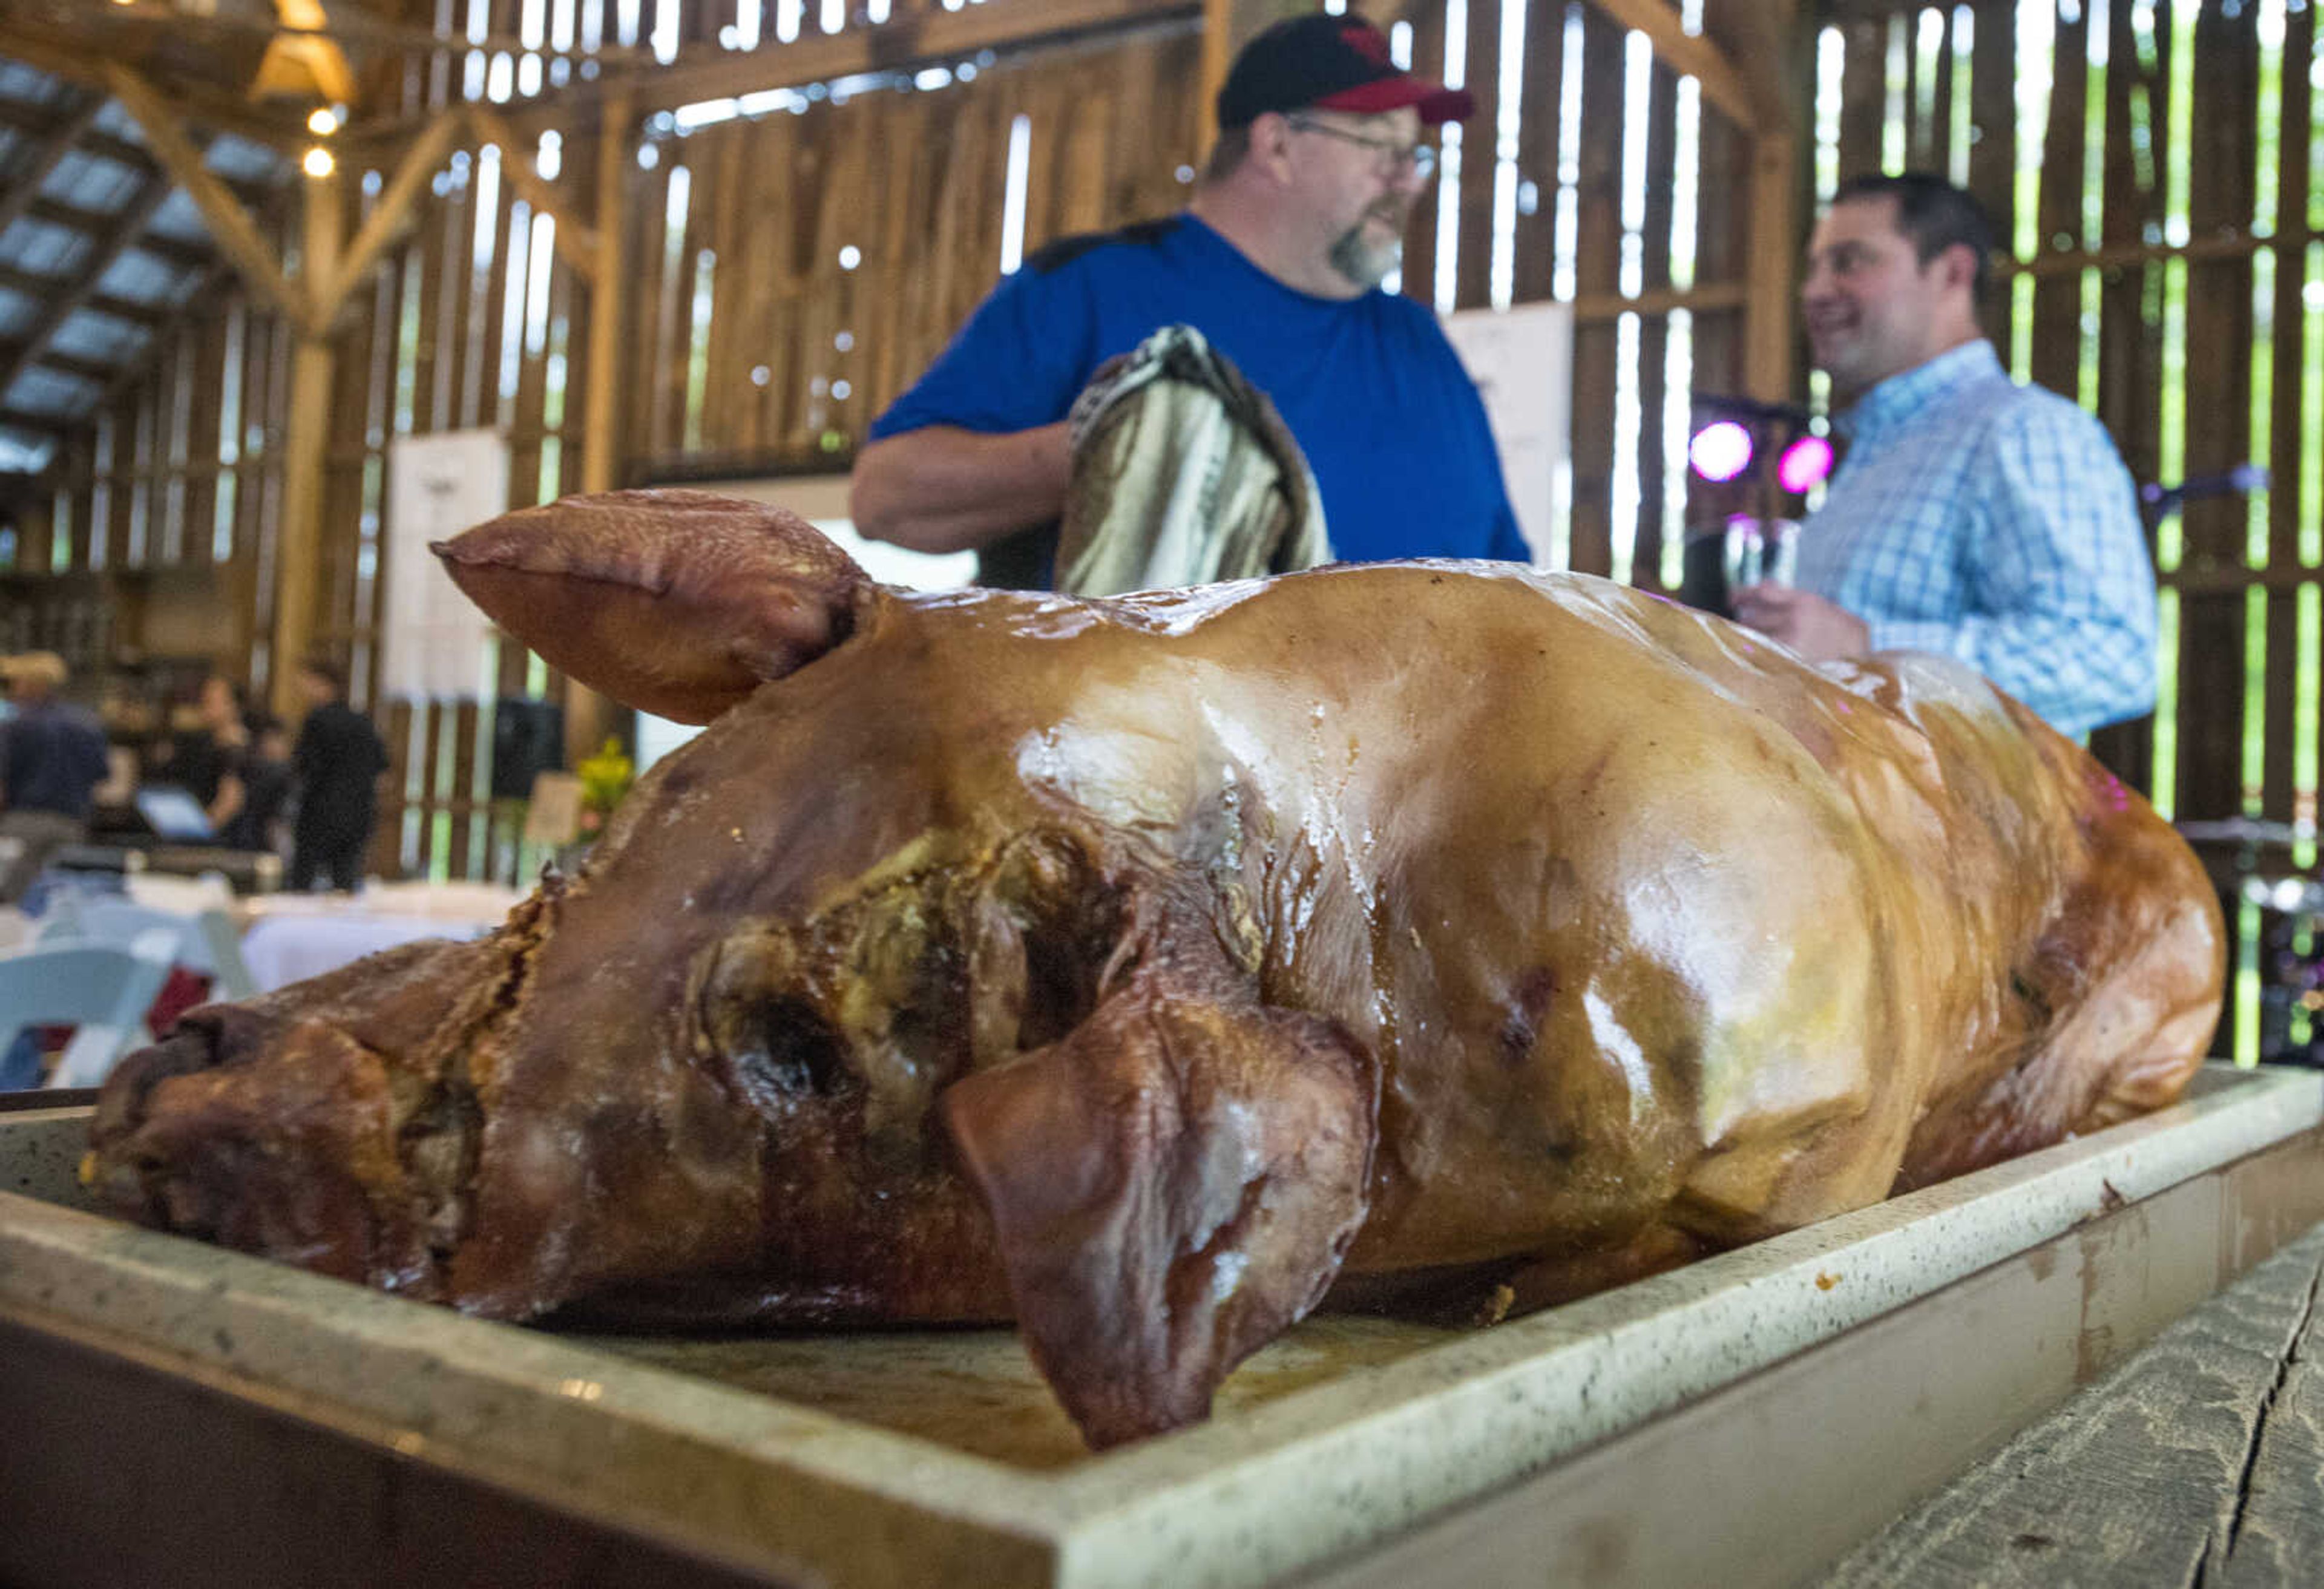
[1822,1229,2324,1589]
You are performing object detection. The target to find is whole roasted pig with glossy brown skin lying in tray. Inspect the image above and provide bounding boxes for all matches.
[93,493,2224,1445]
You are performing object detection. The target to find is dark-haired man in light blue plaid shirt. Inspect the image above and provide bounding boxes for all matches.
[1734,172,2155,734]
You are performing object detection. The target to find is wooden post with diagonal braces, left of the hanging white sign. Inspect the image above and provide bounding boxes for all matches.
[268,172,341,722]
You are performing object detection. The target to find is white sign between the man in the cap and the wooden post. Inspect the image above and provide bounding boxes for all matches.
[1443,302,1574,567]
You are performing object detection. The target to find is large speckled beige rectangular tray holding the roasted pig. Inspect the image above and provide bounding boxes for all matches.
[0,1066,2324,1589]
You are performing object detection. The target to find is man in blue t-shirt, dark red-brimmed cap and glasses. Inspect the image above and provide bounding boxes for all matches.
[853,14,1529,585]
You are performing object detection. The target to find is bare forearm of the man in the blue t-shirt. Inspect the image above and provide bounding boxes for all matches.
[849,421,1074,553]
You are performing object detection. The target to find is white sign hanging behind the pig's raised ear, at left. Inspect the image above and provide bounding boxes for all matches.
[379,430,509,699]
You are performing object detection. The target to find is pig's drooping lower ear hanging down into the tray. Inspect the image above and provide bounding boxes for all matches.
[944,988,1378,1447]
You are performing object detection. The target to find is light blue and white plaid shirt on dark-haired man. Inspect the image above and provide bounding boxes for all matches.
[1799,339,2155,734]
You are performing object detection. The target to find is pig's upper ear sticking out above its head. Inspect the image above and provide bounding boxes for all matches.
[435,490,872,722]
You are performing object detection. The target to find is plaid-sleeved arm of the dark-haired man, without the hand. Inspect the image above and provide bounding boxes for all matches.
[1871,402,2155,734]
